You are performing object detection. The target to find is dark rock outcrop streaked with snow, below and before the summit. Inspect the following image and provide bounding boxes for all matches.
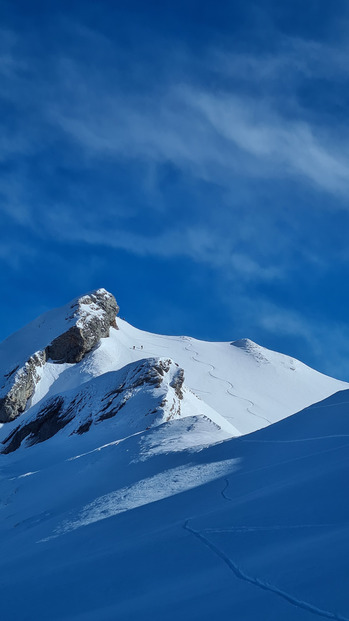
[0,358,184,454]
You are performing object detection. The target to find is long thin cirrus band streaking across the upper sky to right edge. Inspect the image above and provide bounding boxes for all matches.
[53,81,349,195]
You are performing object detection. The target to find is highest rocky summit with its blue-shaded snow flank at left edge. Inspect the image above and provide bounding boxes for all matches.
[0,289,119,422]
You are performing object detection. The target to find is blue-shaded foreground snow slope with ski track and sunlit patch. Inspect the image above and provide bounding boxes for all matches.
[0,391,349,621]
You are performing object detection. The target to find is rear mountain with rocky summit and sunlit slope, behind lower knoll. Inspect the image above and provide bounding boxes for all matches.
[0,289,348,435]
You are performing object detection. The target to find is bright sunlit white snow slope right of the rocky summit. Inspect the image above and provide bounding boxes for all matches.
[31,319,348,434]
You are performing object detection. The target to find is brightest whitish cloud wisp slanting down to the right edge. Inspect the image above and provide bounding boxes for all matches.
[186,93,349,194]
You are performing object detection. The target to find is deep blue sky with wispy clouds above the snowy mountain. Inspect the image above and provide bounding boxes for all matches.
[0,0,349,379]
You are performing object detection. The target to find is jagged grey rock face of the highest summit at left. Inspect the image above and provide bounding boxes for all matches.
[0,289,119,423]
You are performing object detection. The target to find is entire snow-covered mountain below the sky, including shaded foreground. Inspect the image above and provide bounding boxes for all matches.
[0,289,349,621]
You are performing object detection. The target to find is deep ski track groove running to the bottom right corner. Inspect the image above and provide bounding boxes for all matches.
[183,520,349,621]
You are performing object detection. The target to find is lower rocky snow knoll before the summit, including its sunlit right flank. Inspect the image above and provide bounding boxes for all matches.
[0,358,239,454]
